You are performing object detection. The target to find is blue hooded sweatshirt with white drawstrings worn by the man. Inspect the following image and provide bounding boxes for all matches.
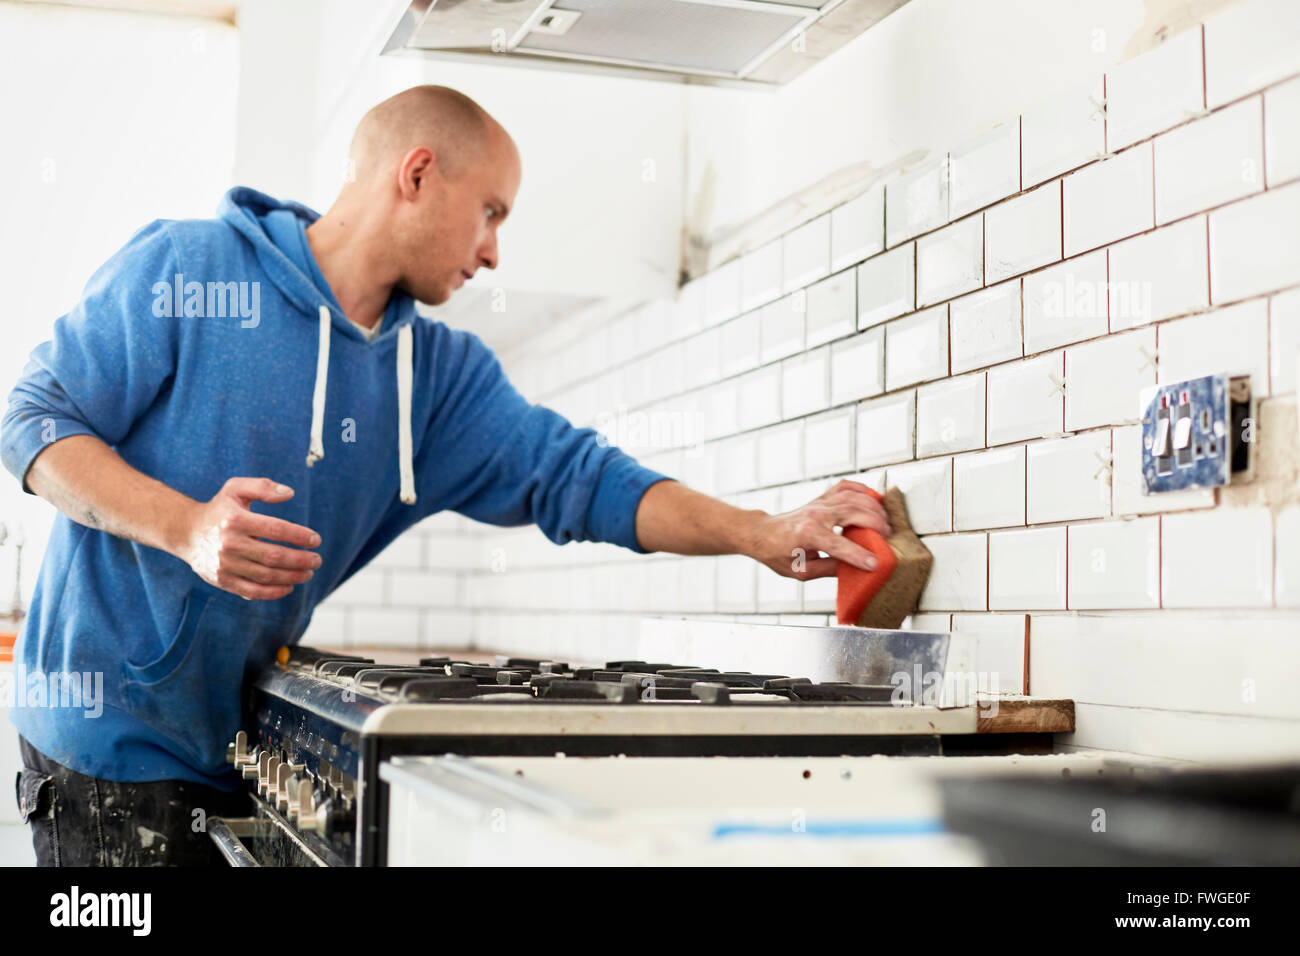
[0,187,667,790]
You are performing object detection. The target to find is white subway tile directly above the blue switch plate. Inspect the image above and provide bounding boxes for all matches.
[1156,299,1269,397]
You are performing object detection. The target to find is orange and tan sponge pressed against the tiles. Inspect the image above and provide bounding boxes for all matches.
[835,488,933,628]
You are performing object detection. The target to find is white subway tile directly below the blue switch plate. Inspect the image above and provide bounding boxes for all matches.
[1161,507,1273,607]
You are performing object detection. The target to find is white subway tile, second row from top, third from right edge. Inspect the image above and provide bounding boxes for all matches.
[1065,143,1156,256]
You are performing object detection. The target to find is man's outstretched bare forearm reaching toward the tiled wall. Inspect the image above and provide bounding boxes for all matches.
[637,480,768,557]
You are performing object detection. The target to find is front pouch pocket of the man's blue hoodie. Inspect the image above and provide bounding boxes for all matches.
[122,591,263,774]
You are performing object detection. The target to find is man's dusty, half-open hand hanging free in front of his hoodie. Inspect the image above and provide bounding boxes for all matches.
[179,477,321,601]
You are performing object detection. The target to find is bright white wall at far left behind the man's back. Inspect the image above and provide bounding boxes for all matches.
[0,3,239,613]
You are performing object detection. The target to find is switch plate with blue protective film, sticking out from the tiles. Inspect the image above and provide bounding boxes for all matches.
[1141,373,1255,494]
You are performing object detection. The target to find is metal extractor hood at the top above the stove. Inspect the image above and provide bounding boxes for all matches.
[384,0,907,87]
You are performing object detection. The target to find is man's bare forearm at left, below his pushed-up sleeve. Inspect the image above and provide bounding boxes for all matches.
[27,434,200,557]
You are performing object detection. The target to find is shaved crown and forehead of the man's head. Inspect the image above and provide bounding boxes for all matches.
[350,86,510,182]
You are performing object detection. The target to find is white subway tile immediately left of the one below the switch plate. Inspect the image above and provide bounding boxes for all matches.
[1069,518,1160,610]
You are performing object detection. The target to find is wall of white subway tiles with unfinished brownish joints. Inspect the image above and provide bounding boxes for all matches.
[312,3,1300,757]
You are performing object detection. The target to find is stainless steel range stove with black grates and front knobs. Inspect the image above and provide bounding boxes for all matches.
[209,622,993,866]
